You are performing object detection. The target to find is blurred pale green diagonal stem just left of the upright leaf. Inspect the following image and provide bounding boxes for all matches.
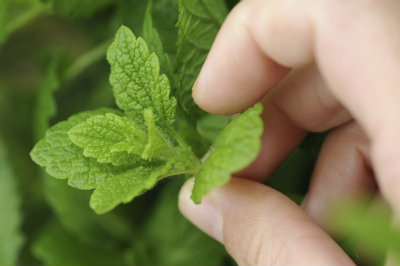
[63,40,111,82]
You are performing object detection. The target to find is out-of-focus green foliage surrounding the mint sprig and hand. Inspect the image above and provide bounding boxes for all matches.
[0,0,400,265]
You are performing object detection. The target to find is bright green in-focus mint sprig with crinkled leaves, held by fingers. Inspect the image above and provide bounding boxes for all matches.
[31,26,263,214]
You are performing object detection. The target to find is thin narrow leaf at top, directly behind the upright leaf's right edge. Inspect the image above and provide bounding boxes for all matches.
[142,1,172,78]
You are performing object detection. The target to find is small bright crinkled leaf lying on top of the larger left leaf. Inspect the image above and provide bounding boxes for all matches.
[68,113,147,166]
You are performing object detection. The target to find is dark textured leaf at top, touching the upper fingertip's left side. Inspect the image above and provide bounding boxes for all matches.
[175,0,228,115]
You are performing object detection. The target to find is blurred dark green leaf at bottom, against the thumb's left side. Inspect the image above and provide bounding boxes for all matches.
[127,178,228,266]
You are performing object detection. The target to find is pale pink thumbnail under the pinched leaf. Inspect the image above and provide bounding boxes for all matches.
[179,178,223,243]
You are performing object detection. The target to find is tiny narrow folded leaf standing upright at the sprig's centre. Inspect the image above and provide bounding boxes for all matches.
[142,109,177,160]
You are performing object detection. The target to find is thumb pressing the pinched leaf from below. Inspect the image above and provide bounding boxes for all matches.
[179,178,353,265]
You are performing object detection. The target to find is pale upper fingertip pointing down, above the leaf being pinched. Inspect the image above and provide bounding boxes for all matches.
[193,1,289,114]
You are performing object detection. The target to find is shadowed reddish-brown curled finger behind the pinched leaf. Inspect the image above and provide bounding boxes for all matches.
[238,65,351,181]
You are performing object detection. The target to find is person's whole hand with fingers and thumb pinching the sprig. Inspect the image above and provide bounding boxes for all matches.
[179,0,400,265]
